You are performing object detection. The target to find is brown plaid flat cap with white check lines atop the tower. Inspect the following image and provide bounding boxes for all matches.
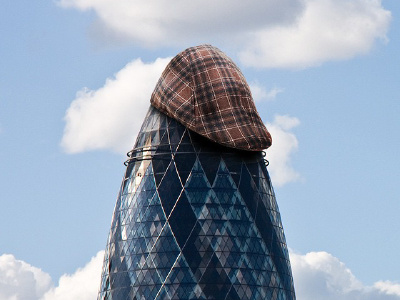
[150,45,272,151]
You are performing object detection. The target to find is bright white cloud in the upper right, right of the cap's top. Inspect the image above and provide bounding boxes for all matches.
[239,0,391,68]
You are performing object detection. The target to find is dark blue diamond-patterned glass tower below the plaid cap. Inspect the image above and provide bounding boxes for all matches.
[98,107,295,300]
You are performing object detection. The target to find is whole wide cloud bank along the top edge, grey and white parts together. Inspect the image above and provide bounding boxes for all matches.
[59,0,391,68]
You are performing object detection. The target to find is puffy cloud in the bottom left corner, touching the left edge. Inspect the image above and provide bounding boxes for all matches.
[0,254,52,300]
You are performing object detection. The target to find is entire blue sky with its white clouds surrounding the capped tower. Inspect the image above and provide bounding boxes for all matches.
[0,0,400,300]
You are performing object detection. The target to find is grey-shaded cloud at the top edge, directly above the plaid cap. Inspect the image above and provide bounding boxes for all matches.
[59,0,302,46]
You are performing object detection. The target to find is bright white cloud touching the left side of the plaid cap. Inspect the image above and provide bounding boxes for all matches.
[61,58,170,153]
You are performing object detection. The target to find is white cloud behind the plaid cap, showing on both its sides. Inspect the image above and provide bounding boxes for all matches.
[61,58,300,186]
